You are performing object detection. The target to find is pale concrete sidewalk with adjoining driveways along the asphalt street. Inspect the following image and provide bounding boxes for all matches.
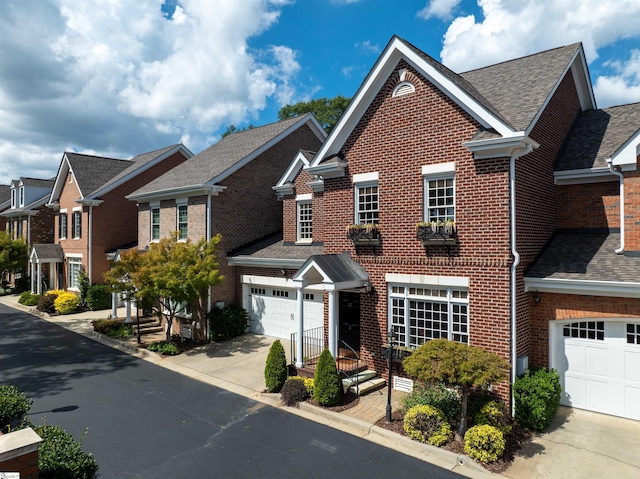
[0,296,640,479]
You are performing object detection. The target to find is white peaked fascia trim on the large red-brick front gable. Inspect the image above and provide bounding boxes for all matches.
[311,37,514,168]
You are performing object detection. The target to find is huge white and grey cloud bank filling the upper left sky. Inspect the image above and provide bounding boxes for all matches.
[0,0,300,182]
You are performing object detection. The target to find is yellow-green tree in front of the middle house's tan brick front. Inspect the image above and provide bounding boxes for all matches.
[104,232,224,341]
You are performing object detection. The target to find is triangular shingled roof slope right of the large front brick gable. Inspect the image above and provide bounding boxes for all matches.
[460,43,581,131]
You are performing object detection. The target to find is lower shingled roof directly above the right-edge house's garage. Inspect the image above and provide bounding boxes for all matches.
[525,233,640,283]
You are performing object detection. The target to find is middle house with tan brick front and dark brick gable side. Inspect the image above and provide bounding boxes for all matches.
[127,114,326,336]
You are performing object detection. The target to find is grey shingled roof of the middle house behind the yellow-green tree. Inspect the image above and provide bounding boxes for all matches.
[131,115,309,197]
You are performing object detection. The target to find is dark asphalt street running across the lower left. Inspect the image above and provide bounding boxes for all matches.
[0,305,462,479]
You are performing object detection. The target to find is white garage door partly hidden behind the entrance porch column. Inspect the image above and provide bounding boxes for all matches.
[244,285,324,339]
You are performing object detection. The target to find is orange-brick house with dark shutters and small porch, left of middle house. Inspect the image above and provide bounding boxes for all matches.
[30,144,192,293]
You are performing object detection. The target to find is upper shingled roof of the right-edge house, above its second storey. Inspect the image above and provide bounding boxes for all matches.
[556,103,640,171]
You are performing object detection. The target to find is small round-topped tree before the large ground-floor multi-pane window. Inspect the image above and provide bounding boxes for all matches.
[402,339,510,438]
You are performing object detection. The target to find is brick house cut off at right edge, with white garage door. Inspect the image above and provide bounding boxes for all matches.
[524,103,640,419]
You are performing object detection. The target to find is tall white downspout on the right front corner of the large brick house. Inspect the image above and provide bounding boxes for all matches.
[509,143,532,415]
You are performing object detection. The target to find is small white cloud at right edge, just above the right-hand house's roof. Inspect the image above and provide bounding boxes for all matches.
[593,50,640,108]
